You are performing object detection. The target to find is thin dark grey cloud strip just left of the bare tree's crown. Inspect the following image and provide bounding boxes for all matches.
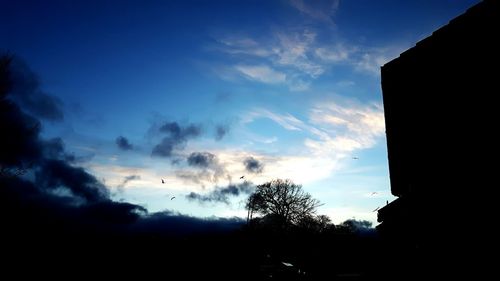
[186,181,255,204]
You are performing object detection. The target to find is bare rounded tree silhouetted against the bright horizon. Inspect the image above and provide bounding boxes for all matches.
[246,179,321,226]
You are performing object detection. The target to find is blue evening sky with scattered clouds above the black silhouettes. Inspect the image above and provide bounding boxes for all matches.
[0,0,478,224]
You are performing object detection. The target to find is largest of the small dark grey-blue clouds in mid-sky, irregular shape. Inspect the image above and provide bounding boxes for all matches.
[151,122,201,158]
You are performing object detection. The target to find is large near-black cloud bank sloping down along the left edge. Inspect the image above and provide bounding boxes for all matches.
[0,54,109,202]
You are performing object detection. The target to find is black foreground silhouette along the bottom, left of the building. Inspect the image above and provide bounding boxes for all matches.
[0,182,381,280]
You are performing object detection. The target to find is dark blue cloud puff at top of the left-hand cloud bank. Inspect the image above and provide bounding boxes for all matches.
[9,54,64,121]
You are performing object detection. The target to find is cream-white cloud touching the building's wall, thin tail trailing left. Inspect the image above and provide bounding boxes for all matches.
[242,101,385,159]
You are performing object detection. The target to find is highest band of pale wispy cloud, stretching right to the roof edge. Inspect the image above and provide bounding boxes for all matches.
[216,27,409,86]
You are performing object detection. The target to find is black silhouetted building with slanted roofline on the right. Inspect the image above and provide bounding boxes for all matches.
[377,0,500,276]
